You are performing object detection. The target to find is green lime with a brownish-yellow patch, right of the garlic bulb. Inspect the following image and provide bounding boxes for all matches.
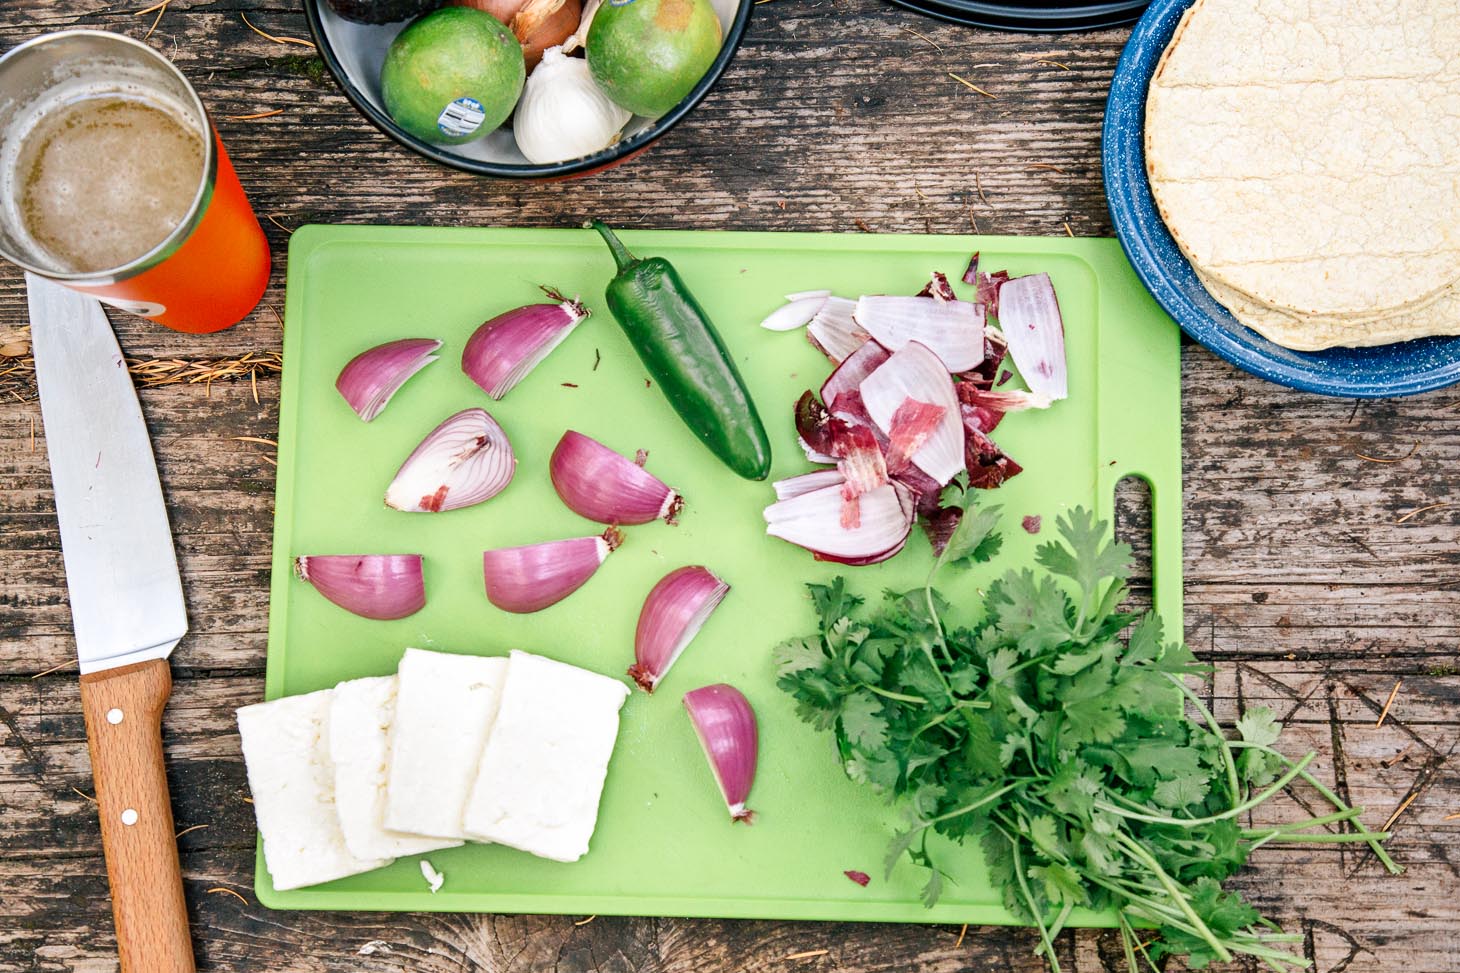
[585,0,720,118]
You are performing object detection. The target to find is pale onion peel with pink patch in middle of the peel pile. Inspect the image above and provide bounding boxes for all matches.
[861,343,963,485]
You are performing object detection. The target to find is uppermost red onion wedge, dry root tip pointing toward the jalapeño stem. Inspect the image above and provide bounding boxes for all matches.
[461,288,590,399]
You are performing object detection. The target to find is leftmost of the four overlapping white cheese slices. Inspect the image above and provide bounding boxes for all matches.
[238,680,390,891]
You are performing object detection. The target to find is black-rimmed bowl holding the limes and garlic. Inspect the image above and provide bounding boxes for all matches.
[304,0,755,180]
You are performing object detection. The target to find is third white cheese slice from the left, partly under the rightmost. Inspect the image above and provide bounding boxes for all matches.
[385,649,507,839]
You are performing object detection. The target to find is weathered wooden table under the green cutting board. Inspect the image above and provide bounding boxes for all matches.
[0,0,1460,973]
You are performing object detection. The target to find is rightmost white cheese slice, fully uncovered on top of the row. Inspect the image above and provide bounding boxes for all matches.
[466,652,629,862]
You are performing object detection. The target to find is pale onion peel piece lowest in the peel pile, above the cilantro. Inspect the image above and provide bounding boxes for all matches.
[765,482,915,562]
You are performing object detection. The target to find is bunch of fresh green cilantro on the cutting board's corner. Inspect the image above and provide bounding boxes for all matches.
[775,508,1399,973]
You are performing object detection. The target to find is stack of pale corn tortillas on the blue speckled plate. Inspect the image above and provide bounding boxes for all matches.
[1146,0,1460,351]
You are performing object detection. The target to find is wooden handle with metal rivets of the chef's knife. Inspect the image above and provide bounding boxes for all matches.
[82,659,194,973]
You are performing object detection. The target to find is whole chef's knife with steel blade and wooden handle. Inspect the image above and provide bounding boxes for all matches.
[25,273,194,973]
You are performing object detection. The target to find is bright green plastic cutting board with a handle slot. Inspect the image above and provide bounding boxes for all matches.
[256,226,1181,925]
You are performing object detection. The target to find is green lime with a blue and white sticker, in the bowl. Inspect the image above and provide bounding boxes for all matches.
[380,7,527,145]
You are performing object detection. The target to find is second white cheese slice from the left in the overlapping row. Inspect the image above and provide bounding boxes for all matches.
[330,676,461,858]
